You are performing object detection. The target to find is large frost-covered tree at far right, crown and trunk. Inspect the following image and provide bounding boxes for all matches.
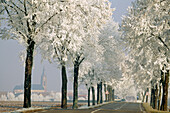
[121,0,170,110]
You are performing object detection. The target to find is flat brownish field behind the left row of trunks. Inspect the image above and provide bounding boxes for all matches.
[0,101,85,112]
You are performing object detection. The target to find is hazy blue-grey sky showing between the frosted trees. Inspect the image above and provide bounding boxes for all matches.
[0,0,134,92]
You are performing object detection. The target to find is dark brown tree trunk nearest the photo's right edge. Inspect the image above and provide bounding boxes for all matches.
[161,70,169,111]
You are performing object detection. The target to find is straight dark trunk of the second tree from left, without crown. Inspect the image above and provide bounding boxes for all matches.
[61,65,67,109]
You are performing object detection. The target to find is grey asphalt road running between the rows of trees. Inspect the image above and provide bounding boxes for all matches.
[38,102,146,113]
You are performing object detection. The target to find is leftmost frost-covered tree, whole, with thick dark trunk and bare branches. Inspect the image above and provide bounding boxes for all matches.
[0,0,60,108]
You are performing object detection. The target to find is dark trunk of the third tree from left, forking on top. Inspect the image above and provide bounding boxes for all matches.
[73,63,79,109]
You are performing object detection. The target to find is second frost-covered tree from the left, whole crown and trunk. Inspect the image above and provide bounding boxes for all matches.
[37,1,84,108]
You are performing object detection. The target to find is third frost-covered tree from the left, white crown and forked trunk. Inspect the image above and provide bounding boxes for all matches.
[72,0,112,109]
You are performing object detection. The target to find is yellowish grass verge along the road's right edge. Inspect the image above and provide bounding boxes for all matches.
[143,103,170,113]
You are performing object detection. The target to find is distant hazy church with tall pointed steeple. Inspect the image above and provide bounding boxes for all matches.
[13,69,47,94]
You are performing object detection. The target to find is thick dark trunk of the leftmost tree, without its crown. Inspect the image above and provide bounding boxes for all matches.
[23,39,35,108]
